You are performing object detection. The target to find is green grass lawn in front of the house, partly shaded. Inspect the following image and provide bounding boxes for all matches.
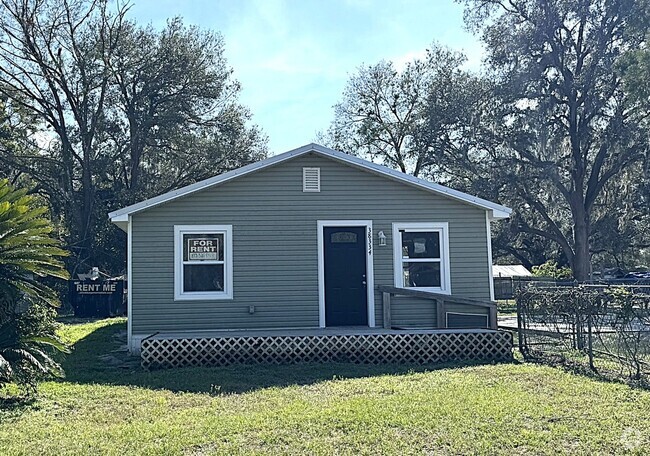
[0,319,650,456]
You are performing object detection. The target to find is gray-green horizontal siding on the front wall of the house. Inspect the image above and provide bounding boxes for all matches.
[131,154,489,335]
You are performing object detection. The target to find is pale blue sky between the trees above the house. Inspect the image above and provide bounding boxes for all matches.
[130,0,481,155]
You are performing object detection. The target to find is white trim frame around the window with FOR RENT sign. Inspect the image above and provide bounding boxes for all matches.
[174,225,233,301]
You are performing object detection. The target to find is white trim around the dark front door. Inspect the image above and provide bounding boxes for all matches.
[316,220,375,328]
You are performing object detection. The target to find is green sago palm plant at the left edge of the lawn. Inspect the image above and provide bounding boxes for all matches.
[0,180,68,390]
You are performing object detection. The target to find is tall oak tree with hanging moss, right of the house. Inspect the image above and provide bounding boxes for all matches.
[465,0,648,280]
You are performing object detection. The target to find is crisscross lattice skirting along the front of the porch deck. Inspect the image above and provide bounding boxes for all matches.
[141,331,512,368]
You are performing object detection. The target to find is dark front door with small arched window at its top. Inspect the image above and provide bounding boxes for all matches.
[323,226,368,326]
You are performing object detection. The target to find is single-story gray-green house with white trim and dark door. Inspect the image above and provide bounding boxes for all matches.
[109,144,511,366]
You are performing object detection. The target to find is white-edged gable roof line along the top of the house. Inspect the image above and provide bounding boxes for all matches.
[108,143,512,227]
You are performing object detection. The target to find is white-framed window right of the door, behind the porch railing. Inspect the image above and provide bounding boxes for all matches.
[393,222,451,294]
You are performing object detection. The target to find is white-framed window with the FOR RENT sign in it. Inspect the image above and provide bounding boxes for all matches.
[174,225,232,300]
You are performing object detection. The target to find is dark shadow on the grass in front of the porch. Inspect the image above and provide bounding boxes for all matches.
[62,322,516,394]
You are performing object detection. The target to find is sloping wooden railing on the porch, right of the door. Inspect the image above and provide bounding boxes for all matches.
[377,285,497,329]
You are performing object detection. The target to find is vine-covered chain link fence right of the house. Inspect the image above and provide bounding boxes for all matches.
[514,283,650,385]
